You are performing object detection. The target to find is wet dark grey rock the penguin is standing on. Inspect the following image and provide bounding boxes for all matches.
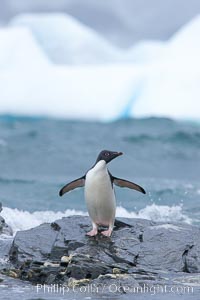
[0,204,200,294]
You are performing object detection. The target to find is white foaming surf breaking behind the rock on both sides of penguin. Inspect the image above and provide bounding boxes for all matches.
[1,204,192,233]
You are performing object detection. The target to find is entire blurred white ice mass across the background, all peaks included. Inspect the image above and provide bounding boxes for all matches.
[0,14,200,121]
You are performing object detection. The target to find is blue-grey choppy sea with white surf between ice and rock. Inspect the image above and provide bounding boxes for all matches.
[0,115,200,232]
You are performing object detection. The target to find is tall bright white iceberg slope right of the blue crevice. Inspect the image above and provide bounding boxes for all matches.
[133,16,200,120]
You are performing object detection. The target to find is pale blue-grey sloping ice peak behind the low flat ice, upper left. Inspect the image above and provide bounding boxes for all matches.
[11,13,122,65]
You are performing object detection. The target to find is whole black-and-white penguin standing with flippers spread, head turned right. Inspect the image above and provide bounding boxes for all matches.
[59,150,146,236]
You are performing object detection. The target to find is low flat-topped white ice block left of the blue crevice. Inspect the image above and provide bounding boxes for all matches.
[0,65,144,121]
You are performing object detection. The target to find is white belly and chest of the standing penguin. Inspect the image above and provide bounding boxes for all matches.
[85,160,116,226]
